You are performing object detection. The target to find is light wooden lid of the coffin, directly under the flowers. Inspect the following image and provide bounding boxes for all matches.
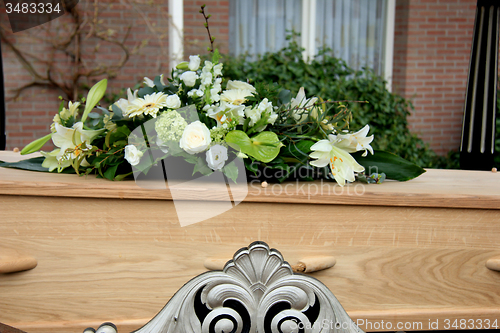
[0,152,500,209]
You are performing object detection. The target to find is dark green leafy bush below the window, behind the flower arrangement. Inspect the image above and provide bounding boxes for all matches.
[224,36,443,167]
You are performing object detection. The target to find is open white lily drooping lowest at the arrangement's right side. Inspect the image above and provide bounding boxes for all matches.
[309,134,365,186]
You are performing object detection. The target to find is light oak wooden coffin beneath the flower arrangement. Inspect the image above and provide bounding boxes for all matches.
[0,152,500,333]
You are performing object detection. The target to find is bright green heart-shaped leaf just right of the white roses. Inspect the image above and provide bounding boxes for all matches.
[226,130,282,163]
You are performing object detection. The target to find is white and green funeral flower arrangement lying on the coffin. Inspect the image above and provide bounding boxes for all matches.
[3,51,423,186]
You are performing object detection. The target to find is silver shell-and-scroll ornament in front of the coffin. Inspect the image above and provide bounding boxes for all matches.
[86,242,363,333]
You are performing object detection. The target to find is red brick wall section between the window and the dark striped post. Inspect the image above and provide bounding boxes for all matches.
[393,0,476,154]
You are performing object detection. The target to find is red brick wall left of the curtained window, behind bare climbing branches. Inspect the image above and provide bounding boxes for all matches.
[0,0,229,150]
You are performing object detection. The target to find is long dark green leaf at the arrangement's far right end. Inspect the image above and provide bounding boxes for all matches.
[352,150,425,181]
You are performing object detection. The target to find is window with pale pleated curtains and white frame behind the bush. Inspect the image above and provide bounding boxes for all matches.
[229,0,395,87]
